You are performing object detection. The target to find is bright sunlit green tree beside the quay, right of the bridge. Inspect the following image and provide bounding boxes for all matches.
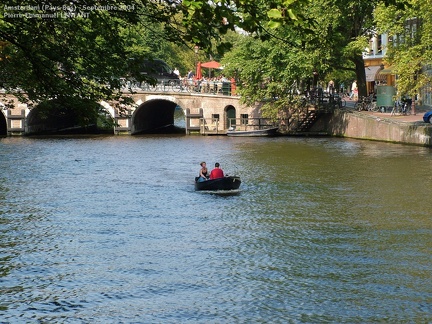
[224,0,408,119]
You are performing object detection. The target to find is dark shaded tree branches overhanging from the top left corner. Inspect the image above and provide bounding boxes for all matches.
[0,0,306,106]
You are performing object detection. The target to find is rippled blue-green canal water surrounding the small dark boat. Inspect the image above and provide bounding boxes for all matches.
[0,135,432,323]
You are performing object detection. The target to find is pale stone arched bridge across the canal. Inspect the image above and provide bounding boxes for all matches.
[0,91,260,136]
